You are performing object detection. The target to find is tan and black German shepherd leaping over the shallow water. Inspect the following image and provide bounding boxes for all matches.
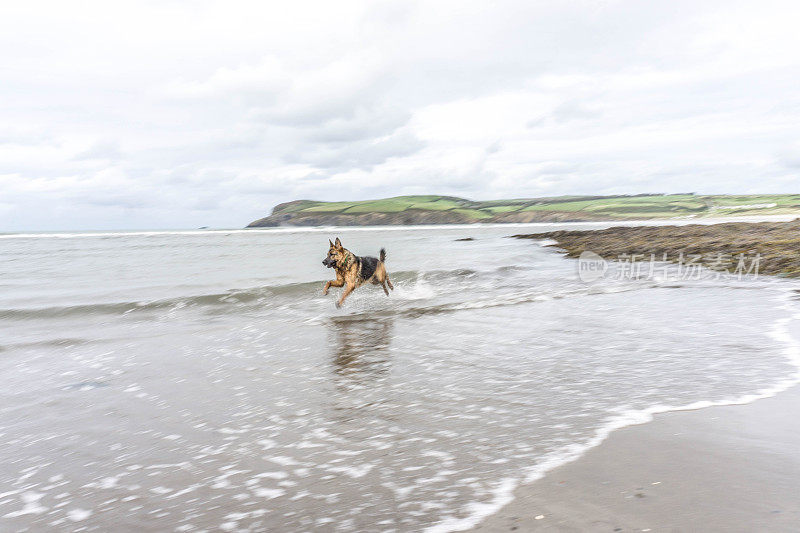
[322,237,394,307]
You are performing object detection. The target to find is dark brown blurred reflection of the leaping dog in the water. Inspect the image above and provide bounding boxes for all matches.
[330,318,393,386]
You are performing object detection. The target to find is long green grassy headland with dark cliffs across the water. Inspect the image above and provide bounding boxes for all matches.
[248,193,800,227]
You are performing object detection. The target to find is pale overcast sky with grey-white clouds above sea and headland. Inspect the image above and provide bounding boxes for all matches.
[0,0,800,231]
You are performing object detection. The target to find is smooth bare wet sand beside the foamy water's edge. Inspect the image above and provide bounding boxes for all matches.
[476,386,800,532]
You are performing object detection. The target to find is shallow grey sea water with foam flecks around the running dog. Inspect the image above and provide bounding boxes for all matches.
[0,225,797,531]
